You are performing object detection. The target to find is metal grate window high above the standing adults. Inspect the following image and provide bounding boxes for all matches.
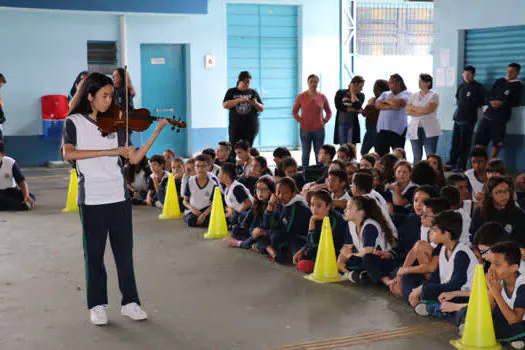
[355,0,434,56]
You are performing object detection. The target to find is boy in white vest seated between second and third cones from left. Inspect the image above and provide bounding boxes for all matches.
[183,154,219,227]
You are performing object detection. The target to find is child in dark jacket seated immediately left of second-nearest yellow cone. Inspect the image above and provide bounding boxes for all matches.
[264,177,312,263]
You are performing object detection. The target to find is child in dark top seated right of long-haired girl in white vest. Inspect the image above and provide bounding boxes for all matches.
[376,185,437,300]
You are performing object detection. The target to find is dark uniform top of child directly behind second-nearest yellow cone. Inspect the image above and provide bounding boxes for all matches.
[303,210,352,260]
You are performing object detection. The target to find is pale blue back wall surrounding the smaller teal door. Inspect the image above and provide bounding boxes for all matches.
[0,0,339,165]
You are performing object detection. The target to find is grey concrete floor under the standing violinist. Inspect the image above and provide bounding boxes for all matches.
[0,169,456,350]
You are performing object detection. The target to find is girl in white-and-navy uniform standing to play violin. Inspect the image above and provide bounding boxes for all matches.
[62,73,168,325]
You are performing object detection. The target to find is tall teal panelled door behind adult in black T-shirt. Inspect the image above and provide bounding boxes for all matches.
[227,4,299,150]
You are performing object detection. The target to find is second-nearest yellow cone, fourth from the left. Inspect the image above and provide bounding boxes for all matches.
[304,216,343,283]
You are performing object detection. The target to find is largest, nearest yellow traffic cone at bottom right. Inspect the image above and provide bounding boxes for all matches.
[450,265,501,350]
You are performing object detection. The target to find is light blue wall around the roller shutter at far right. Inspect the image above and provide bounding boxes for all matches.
[434,0,525,172]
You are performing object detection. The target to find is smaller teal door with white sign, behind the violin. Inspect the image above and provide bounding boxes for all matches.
[138,44,187,157]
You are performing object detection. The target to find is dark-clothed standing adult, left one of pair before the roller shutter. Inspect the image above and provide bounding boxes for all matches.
[447,66,485,173]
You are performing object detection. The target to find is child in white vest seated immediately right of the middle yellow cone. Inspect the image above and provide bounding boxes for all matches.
[219,163,253,225]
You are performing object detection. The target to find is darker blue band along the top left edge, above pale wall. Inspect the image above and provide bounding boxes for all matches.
[0,0,208,14]
